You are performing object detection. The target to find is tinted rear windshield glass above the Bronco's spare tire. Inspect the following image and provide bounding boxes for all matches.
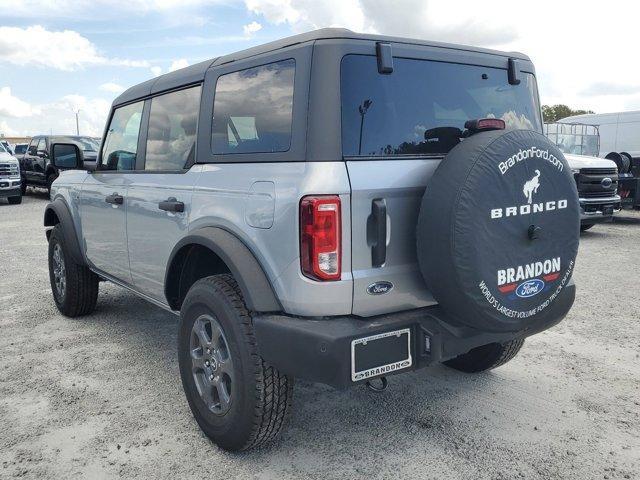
[341,55,542,156]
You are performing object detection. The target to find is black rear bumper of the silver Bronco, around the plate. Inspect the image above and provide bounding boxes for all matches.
[254,282,575,388]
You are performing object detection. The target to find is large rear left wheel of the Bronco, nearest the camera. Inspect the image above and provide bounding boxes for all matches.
[178,275,293,451]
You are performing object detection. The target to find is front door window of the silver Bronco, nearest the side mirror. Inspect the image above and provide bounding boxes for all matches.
[100,102,144,170]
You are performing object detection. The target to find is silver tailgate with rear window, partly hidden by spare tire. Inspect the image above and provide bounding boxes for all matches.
[341,45,542,316]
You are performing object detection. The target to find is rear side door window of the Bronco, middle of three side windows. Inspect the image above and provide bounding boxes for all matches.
[145,86,201,170]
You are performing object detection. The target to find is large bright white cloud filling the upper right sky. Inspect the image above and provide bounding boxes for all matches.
[245,0,640,112]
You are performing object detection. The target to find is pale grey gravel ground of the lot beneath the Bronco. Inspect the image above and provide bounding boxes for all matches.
[0,193,640,479]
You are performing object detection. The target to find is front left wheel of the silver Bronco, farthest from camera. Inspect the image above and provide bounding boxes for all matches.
[49,224,99,317]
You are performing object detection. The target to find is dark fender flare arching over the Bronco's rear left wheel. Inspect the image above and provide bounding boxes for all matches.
[164,227,282,312]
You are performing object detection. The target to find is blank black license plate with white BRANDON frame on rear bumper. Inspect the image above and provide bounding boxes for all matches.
[351,328,413,382]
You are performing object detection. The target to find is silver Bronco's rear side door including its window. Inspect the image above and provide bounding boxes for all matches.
[125,85,202,303]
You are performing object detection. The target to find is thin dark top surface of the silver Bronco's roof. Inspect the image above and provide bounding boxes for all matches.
[113,28,529,106]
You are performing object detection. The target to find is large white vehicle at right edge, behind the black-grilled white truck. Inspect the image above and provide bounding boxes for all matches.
[560,110,640,208]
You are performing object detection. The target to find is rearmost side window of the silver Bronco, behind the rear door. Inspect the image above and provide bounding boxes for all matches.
[212,60,295,153]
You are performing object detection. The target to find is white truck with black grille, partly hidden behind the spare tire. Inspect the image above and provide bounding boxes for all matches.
[545,123,621,231]
